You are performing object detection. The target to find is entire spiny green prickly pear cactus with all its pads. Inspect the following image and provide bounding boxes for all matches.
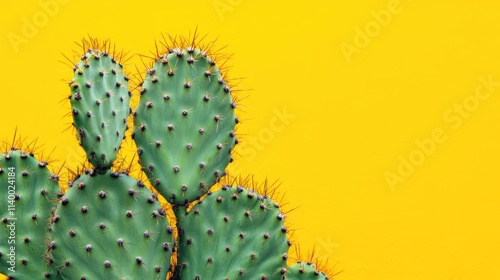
[0,36,336,280]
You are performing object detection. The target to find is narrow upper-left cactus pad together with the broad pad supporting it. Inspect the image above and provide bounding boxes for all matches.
[49,40,174,279]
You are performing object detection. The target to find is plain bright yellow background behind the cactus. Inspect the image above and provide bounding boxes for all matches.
[0,0,500,280]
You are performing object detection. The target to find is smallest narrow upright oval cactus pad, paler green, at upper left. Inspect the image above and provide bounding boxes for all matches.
[70,49,130,170]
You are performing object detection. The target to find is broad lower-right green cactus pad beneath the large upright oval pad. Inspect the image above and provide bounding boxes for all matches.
[176,187,290,280]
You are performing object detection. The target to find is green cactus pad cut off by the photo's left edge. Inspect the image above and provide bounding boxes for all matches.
[0,150,60,279]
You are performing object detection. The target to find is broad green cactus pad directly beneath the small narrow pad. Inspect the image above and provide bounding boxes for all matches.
[49,171,174,280]
